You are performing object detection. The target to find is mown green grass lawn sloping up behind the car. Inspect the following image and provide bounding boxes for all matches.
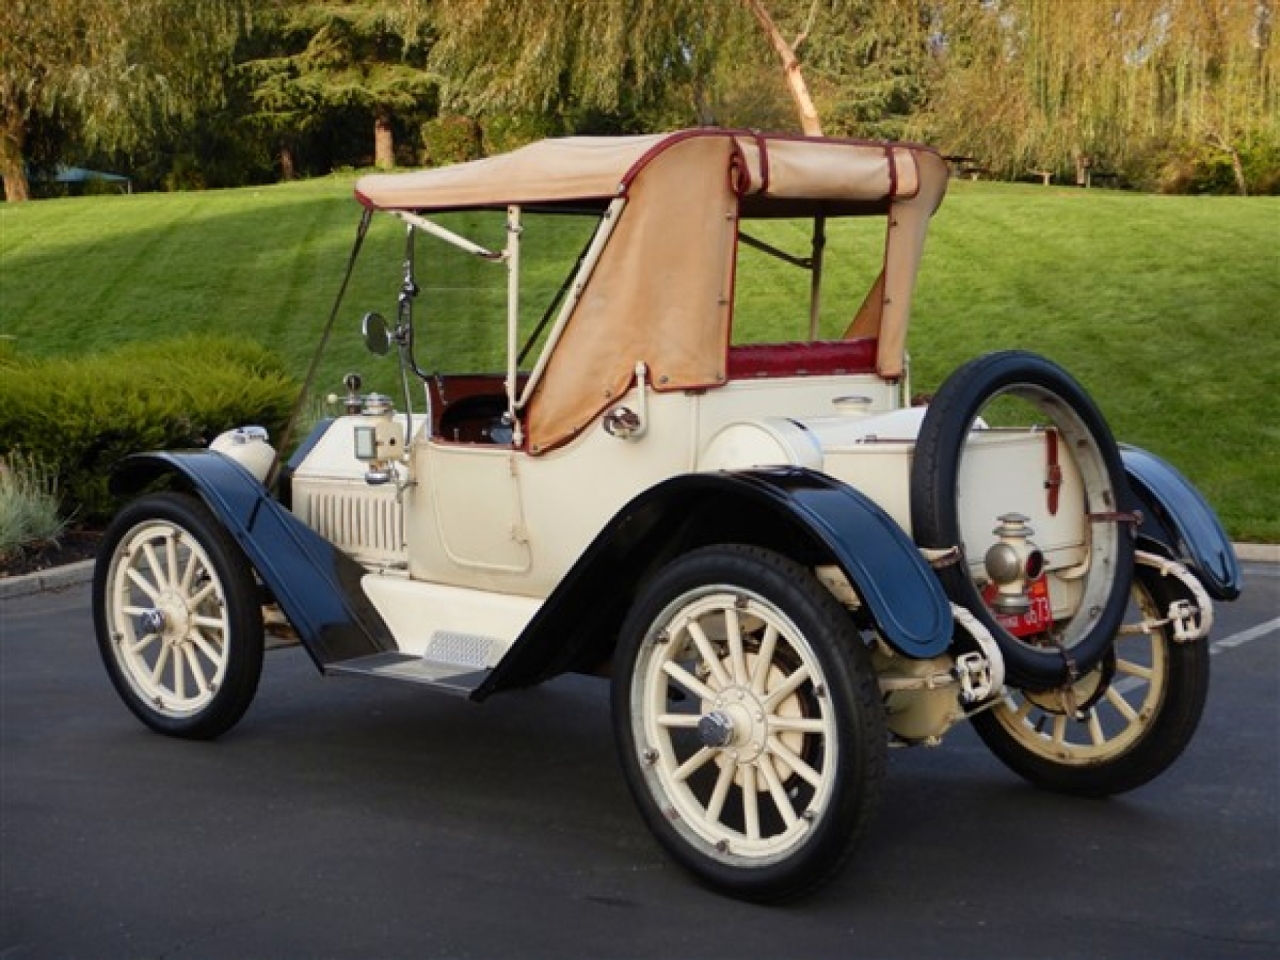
[0,178,1280,541]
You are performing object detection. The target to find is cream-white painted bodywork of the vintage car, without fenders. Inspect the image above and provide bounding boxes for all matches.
[293,375,1088,654]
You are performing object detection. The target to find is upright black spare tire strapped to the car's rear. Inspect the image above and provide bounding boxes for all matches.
[911,351,1134,690]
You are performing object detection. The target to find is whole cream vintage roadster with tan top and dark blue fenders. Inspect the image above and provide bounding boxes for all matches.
[93,129,1240,900]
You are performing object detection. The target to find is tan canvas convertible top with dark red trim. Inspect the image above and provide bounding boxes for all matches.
[356,128,947,453]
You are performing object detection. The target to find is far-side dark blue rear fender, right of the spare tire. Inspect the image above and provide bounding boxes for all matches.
[1120,445,1240,600]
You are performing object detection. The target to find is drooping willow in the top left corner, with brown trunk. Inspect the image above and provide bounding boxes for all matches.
[0,0,250,201]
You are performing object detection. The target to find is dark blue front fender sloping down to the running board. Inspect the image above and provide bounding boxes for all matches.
[111,451,396,667]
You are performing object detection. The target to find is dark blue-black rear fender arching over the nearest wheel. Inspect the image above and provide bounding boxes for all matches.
[474,468,954,699]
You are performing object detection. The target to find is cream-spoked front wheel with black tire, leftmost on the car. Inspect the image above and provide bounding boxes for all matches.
[93,493,262,740]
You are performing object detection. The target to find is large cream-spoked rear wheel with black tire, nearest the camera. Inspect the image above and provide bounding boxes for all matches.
[613,545,887,900]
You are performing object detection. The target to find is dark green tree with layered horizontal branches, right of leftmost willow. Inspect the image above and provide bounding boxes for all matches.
[241,0,436,175]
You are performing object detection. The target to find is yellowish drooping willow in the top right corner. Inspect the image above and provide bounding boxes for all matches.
[920,0,1280,192]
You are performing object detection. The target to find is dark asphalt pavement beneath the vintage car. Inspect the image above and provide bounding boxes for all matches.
[0,563,1280,960]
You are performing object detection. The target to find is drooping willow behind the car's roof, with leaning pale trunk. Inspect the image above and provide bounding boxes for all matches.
[433,0,838,136]
